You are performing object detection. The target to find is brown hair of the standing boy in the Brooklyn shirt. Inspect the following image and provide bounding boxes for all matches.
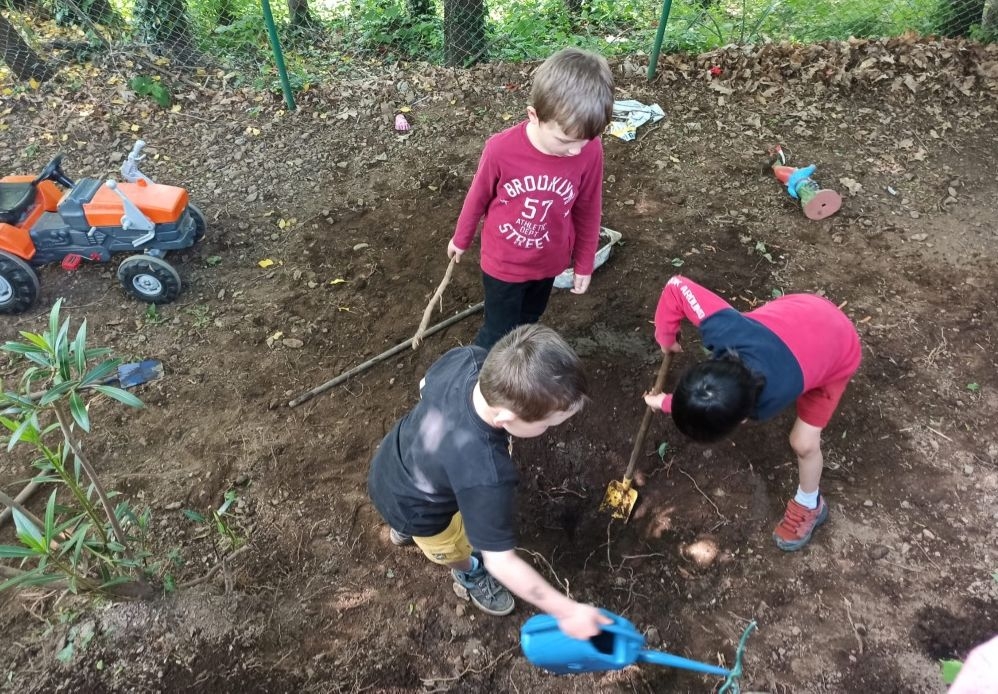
[530,48,613,140]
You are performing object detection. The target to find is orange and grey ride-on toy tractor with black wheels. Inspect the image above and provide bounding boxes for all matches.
[0,140,206,314]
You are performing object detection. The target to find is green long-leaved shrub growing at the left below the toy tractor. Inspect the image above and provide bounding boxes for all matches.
[0,299,149,592]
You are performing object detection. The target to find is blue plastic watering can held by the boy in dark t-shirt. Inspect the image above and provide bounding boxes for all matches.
[520,610,755,692]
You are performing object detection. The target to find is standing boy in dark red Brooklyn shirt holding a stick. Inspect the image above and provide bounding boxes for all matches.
[447,48,613,349]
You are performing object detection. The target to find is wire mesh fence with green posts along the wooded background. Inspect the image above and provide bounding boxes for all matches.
[0,0,998,92]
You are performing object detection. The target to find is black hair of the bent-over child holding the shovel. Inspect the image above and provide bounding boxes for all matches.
[672,350,765,443]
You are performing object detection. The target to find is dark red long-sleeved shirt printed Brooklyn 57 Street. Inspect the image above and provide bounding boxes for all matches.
[453,121,603,282]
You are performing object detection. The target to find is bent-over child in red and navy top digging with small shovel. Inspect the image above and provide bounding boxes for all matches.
[644,275,862,552]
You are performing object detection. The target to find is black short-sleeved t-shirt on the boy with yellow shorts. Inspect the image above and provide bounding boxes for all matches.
[367,347,519,552]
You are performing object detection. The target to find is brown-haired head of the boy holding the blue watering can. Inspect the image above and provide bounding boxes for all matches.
[478,323,589,422]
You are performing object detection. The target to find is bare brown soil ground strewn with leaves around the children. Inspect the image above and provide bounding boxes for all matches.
[0,39,998,694]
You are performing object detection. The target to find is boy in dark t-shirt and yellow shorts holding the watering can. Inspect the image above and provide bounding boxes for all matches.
[368,324,610,639]
